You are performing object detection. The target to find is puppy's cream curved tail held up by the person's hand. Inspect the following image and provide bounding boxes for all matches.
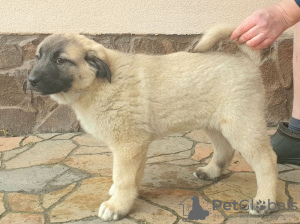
[193,24,260,64]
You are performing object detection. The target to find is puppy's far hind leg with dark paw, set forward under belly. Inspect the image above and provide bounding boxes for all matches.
[194,130,234,180]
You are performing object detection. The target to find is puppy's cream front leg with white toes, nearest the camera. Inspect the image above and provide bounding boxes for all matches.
[99,142,148,221]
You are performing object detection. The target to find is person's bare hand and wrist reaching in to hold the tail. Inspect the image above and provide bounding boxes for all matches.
[230,0,300,49]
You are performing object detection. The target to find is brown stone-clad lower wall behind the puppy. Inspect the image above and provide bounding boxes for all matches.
[0,34,293,135]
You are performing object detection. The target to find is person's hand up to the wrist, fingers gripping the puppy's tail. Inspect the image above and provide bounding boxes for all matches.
[230,5,291,49]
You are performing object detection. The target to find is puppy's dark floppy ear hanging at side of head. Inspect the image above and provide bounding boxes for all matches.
[84,51,111,83]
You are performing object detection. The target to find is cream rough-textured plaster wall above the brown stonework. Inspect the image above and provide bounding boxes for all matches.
[0,0,278,34]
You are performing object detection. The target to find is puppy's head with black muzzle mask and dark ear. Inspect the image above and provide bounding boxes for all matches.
[28,34,111,95]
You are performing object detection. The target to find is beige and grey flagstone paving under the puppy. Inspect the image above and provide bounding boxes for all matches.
[0,129,300,224]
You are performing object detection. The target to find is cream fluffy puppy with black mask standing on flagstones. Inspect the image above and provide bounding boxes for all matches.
[28,25,277,220]
